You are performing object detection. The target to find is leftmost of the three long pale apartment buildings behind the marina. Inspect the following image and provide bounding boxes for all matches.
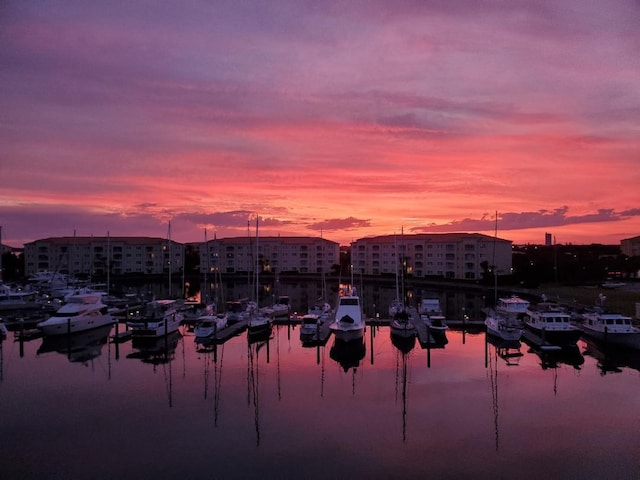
[24,237,185,276]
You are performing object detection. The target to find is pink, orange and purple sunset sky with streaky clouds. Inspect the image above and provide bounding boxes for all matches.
[0,0,640,247]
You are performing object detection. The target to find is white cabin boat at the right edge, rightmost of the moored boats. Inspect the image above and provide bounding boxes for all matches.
[578,312,640,349]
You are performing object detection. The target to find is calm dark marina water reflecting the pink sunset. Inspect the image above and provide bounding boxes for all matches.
[0,286,640,479]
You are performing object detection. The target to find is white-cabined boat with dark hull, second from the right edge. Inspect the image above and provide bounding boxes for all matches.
[523,303,580,347]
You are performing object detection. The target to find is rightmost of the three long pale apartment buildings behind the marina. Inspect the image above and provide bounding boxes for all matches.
[351,233,512,280]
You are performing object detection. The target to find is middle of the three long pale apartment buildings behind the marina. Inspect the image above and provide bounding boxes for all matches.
[200,237,340,273]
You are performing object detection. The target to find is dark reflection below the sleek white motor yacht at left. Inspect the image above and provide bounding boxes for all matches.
[38,324,112,365]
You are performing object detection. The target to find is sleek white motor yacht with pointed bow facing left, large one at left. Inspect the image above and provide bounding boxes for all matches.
[36,293,114,335]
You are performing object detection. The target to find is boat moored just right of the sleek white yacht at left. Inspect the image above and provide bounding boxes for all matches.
[127,299,183,338]
